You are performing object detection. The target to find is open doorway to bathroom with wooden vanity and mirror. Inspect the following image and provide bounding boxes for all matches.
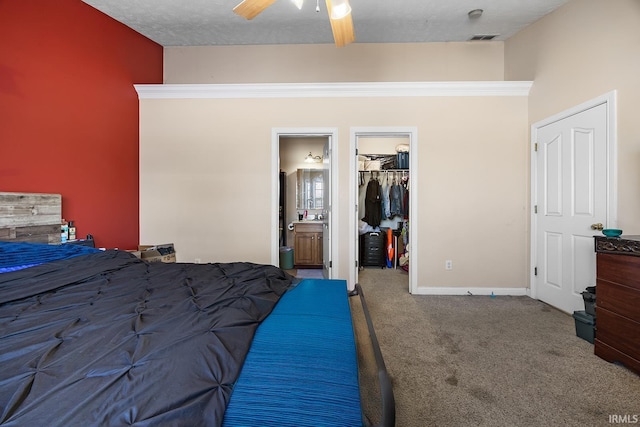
[272,129,337,278]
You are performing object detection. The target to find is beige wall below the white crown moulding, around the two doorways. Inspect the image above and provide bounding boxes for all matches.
[140,92,528,288]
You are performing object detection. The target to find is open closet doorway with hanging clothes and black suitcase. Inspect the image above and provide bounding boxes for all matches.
[349,128,418,293]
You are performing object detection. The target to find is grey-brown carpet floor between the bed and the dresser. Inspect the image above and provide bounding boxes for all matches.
[351,269,640,427]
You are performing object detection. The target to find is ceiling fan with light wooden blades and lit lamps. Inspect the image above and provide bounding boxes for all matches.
[233,0,356,47]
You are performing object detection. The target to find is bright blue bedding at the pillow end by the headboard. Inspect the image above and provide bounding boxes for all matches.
[0,242,99,273]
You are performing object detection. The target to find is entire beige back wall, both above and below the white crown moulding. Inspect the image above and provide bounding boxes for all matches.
[140,42,529,289]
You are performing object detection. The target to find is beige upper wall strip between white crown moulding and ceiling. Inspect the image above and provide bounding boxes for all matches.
[164,42,504,83]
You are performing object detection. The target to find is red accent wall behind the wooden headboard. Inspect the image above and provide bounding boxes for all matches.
[0,0,163,249]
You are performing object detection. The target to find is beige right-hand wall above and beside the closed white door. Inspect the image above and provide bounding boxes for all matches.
[505,0,640,234]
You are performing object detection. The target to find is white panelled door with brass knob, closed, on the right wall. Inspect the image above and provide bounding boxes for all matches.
[535,103,609,313]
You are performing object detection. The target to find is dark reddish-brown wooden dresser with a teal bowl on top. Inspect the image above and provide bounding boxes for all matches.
[595,236,640,374]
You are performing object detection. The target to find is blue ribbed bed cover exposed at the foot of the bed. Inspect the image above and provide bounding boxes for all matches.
[223,279,363,427]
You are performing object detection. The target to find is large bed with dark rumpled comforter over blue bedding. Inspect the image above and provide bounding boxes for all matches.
[0,195,395,426]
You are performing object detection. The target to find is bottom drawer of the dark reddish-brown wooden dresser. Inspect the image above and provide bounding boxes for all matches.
[596,308,640,358]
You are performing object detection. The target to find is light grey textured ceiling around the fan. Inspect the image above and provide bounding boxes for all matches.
[83,0,568,46]
